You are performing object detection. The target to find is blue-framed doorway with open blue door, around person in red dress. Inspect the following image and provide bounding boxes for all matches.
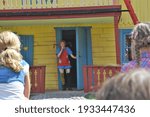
[55,27,93,90]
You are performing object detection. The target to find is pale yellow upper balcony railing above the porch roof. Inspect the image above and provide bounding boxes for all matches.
[0,0,119,10]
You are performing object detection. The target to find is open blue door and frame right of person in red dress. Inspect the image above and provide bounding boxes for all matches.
[76,27,92,89]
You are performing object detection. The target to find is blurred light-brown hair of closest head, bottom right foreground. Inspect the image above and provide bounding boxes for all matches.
[96,68,150,100]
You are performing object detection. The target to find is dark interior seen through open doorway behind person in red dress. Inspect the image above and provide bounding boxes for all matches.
[62,30,77,88]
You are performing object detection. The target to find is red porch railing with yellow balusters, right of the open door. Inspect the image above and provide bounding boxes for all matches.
[83,66,121,92]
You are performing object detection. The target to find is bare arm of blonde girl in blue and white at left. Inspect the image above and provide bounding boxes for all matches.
[24,72,31,99]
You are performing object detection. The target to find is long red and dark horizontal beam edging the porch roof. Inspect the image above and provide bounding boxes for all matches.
[0,6,121,20]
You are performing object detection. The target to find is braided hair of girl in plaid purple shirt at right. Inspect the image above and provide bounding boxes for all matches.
[131,23,150,66]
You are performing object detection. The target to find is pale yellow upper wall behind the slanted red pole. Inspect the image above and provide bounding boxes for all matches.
[119,0,150,28]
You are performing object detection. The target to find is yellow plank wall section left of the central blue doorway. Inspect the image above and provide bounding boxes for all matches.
[0,26,58,89]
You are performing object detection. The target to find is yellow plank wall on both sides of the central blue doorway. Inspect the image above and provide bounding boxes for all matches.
[0,24,116,90]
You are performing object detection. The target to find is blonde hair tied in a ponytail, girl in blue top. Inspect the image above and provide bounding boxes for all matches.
[0,31,23,72]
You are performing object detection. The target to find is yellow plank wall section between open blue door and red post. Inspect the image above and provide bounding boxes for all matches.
[92,23,116,65]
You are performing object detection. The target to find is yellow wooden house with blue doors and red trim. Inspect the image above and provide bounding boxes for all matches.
[0,0,150,92]
